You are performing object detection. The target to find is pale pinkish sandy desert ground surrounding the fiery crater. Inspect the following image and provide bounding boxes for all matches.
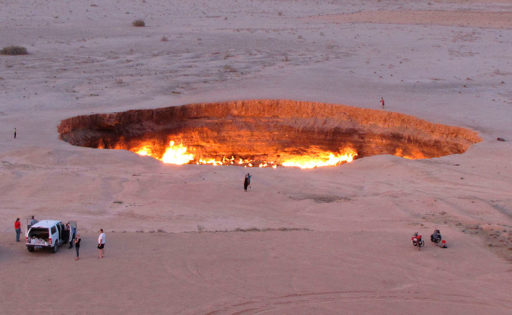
[0,0,512,314]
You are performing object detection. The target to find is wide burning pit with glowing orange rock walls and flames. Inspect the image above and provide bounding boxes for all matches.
[58,100,481,168]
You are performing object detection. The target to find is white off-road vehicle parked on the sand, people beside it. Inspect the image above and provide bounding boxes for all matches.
[25,220,71,253]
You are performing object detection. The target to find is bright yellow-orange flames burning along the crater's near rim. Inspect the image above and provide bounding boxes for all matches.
[130,140,357,169]
